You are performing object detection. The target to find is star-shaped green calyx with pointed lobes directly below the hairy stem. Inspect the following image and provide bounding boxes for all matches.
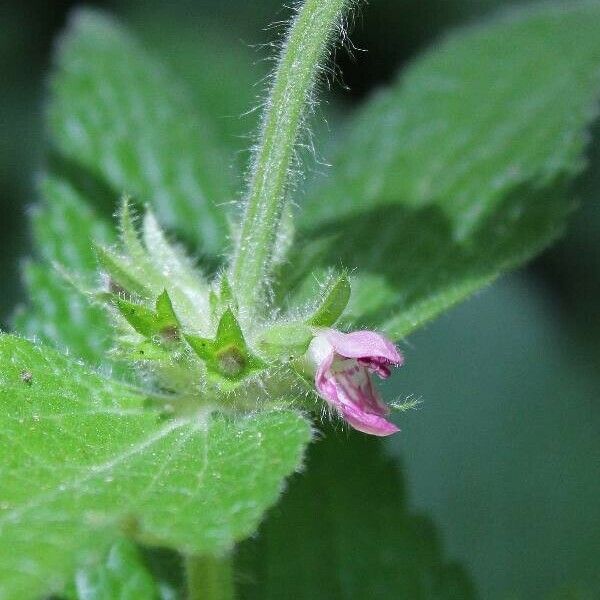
[184,308,266,381]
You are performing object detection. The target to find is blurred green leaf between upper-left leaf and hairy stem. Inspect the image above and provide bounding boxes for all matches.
[128,11,269,161]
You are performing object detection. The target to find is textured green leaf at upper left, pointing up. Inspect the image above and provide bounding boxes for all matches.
[49,10,232,253]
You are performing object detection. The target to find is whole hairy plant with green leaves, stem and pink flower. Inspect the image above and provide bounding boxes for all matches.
[0,0,600,599]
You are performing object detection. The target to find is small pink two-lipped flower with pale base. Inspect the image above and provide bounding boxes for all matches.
[308,329,403,436]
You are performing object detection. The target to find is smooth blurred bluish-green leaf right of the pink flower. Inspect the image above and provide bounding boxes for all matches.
[383,276,600,600]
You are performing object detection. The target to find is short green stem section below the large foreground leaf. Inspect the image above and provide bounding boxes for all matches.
[185,556,235,600]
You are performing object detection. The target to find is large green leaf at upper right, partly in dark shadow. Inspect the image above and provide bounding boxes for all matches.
[298,2,600,338]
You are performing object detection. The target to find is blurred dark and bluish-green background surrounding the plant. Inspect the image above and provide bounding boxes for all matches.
[0,0,600,599]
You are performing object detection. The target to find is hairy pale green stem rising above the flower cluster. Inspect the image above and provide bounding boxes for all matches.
[231,0,350,314]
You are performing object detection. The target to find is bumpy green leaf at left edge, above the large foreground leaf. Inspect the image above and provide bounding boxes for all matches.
[14,177,113,365]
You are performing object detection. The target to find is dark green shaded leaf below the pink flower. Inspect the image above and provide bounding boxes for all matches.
[237,431,475,600]
